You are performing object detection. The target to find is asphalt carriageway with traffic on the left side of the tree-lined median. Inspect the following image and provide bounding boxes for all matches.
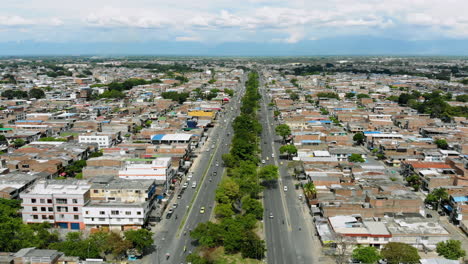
[142,76,249,264]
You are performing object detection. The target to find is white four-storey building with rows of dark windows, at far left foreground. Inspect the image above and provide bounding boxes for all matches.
[20,180,91,230]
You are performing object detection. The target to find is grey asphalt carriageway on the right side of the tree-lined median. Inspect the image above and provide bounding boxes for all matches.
[260,73,320,264]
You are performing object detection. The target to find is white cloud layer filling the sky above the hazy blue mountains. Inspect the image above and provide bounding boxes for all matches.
[0,0,468,43]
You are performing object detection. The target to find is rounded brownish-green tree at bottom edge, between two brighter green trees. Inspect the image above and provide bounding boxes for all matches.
[380,242,420,264]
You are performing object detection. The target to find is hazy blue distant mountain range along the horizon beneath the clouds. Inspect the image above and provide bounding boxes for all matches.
[0,36,468,56]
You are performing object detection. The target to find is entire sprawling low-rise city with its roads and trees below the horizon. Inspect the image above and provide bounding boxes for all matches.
[0,57,468,264]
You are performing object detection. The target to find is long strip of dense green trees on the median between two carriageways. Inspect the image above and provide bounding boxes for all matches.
[187,72,266,264]
